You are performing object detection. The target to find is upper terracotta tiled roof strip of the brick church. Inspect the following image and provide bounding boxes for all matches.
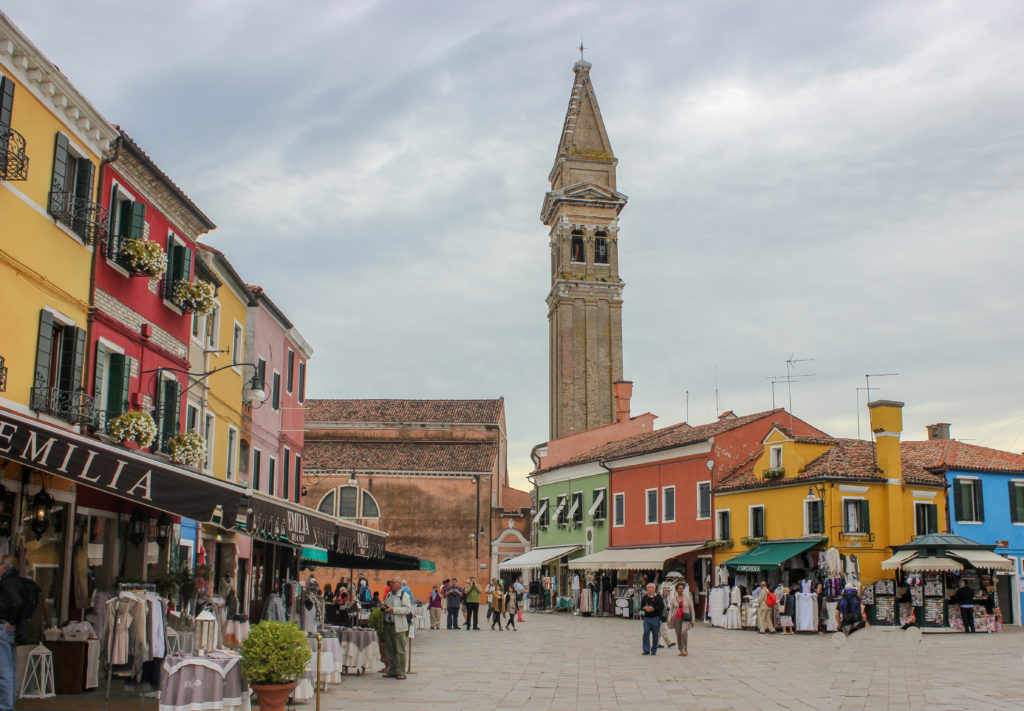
[305,398,505,424]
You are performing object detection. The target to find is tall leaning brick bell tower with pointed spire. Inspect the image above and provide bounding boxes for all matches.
[541,57,627,438]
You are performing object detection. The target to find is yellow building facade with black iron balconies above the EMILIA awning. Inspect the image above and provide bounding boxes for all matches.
[0,12,117,417]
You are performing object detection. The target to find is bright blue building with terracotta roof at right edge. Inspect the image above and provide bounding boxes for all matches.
[901,423,1024,625]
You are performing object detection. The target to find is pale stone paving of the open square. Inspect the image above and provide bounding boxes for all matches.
[317,613,1024,711]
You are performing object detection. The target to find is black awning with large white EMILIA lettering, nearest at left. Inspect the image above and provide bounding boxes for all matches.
[0,409,243,521]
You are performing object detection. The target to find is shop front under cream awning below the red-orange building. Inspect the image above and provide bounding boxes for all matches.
[568,543,707,617]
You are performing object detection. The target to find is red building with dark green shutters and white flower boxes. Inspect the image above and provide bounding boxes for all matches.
[81,132,216,607]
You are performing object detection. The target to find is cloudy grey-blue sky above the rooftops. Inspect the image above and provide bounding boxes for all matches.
[8,0,1024,483]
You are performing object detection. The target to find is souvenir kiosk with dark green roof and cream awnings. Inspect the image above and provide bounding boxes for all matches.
[865,534,1014,632]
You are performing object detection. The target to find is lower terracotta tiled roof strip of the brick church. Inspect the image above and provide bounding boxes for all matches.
[302,440,498,473]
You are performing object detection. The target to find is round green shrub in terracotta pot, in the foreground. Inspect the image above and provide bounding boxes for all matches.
[242,620,312,711]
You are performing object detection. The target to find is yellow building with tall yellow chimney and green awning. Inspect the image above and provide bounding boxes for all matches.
[715,401,946,583]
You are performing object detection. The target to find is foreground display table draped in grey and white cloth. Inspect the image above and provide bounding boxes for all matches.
[160,652,251,711]
